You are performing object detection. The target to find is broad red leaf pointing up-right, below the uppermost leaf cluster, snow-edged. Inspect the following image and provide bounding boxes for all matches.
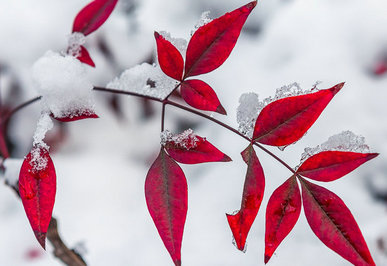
[253,83,344,146]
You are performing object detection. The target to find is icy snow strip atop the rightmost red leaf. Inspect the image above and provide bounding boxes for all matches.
[300,130,370,165]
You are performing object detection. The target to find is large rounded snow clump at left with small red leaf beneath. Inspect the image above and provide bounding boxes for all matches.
[32,51,96,120]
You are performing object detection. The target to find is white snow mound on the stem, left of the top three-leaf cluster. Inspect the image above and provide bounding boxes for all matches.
[107,63,177,99]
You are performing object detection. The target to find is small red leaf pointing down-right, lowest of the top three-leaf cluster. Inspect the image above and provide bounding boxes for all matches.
[181,79,227,115]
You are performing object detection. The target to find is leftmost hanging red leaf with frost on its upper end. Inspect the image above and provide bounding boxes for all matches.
[19,148,56,249]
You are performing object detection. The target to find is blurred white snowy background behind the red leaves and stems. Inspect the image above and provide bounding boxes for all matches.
[0,0,387,266]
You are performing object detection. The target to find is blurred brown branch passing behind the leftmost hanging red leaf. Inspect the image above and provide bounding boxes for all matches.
[5,181,87,266]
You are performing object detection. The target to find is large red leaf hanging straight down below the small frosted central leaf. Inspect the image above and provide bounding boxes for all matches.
[145,149,188,265]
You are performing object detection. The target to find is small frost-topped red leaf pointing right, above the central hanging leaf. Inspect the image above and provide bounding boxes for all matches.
[160,129,231,164]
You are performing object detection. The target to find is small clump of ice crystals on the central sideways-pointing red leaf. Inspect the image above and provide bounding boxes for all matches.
[160,129,199,150]
